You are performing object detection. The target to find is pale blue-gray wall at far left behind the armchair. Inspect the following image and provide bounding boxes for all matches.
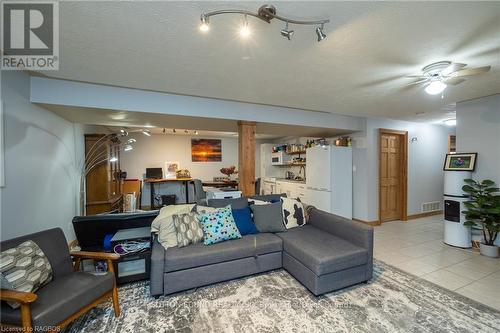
[0,71,82,241]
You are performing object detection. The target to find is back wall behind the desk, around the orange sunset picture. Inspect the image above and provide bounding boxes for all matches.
[120,133,261,206]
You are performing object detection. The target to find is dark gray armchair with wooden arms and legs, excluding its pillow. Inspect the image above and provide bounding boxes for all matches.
[0,228,120,332]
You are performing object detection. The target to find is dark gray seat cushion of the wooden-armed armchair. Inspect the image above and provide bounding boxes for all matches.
[1,272,114,326]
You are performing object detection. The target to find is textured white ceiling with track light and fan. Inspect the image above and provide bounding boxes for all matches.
[40,1,500,120]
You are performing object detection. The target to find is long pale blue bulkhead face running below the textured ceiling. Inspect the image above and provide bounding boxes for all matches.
[31,77,364,131]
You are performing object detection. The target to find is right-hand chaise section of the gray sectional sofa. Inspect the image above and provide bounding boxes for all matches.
[277,209,373,295]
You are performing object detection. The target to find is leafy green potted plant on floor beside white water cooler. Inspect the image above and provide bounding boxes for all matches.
[462,179,500,258]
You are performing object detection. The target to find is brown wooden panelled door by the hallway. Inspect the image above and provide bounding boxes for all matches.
[379,131,406,222]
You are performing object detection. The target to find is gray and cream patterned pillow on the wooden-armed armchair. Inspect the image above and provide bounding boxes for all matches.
[0,240,52,309]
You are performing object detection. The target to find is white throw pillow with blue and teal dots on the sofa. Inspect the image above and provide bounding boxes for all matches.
[198,205,241,245]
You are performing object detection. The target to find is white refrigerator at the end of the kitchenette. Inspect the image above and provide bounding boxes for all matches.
[306,146,352,219]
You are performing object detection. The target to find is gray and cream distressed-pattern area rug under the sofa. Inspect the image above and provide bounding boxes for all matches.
[66,261,500,333]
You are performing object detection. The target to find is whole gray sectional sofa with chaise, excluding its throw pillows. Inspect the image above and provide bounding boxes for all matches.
[150,197,373,296]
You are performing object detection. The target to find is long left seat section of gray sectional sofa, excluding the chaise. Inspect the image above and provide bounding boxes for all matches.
[151,233,283,296]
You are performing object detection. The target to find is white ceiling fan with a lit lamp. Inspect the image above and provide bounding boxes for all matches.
[407,61,491,95]
